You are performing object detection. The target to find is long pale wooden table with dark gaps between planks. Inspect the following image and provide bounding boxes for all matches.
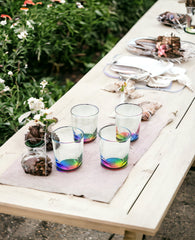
[0,0,195,239]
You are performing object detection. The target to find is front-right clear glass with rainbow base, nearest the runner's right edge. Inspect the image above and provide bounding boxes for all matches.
[99,125,131,169]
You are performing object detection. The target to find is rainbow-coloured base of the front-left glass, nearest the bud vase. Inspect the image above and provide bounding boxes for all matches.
[56,154,82,172]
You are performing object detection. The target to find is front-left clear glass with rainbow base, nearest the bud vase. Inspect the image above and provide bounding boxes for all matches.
[51,126,84,171]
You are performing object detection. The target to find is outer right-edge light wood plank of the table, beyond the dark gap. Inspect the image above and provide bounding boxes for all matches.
[125,99,195,233]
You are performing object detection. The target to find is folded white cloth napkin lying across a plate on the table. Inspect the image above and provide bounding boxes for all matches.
[111,56,193,91]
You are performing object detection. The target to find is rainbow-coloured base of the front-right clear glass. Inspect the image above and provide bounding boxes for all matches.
[100,155,128,169]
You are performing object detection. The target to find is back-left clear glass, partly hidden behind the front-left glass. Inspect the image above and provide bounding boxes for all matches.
[71,104,99,143]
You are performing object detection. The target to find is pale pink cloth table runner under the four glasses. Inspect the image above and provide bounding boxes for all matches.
[0,113,170,203]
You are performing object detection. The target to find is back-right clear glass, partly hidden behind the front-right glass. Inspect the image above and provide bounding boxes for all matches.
[115,103,142,142]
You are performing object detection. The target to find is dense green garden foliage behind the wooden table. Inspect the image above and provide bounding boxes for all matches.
[0,0,156,145]
